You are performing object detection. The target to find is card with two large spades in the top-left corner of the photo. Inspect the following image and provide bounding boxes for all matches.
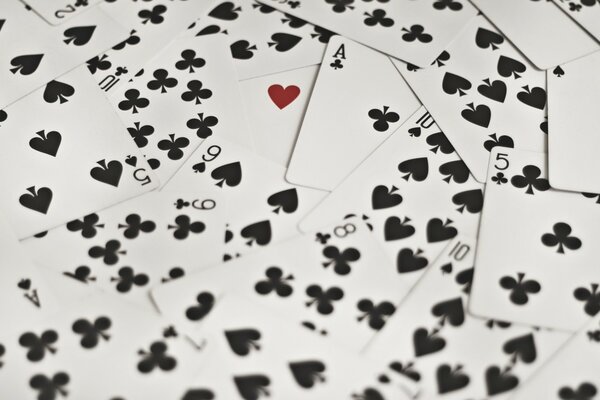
[0,1,127,109]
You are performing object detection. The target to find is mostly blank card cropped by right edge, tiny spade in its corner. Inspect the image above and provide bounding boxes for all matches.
[548,52,600,193]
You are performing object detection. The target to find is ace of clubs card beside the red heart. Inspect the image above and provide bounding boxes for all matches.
[286,36,419,190]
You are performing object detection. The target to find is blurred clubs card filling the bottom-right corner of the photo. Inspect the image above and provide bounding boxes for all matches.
[513,317,600,400]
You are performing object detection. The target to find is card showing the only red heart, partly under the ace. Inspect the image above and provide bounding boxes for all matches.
[240,65,319,167]
